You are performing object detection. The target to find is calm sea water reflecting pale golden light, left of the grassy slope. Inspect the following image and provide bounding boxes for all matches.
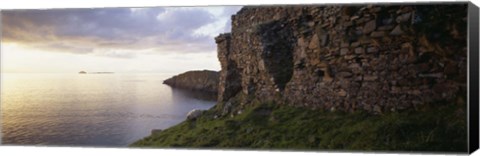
[0,73,215,147]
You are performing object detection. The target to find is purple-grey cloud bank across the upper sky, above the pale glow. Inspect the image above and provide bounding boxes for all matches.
[2,7,239,58]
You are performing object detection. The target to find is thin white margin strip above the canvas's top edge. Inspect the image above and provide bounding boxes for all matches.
[0,0,470,9]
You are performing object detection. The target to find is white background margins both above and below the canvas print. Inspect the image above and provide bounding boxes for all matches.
[0,0,480,156]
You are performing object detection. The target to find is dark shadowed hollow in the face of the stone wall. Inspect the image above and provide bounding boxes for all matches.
[258,21,294,90]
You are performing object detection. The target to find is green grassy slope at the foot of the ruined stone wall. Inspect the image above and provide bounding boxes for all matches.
[131,100,467,152]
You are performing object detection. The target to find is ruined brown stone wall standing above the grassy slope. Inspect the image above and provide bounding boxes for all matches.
[216,3,467,112]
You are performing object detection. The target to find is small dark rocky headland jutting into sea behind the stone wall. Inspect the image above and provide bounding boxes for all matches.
[163,70,219,94]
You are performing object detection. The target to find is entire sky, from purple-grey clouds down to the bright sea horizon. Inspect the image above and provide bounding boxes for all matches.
[1,6,241,73]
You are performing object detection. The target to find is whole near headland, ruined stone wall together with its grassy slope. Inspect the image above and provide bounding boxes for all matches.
[131,3,468,153]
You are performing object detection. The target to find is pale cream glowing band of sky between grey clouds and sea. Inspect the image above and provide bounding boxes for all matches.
[1,43,220,73]
